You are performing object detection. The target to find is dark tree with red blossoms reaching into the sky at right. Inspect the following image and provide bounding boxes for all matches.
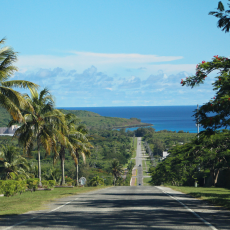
[181,55,230,134]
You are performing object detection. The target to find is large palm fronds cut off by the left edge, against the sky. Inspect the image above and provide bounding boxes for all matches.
[0,39,38,121]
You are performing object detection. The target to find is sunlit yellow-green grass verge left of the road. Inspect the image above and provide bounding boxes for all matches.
[0,187,108,216]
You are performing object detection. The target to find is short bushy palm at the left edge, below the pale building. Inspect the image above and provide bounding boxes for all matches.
[0,145,29,179]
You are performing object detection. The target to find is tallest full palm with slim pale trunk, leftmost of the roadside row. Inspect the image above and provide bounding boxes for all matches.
[12,88,66,186]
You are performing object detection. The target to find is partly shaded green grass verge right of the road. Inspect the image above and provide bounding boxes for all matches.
[167,186,230,209]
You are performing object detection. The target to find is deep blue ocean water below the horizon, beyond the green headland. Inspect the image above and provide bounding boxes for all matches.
[58,105,201,133]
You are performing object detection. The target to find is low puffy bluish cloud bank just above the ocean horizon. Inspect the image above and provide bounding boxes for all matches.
[14,66,213,107]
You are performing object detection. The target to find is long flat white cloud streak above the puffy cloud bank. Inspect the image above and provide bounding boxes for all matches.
[17,51,183,71]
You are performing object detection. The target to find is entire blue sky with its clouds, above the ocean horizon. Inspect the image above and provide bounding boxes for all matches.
[0,0,230,107]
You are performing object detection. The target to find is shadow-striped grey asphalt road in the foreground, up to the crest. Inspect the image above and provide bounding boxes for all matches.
[0,186,230,230]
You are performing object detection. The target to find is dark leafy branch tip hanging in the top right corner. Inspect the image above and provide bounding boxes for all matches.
[209,0,230,33]
